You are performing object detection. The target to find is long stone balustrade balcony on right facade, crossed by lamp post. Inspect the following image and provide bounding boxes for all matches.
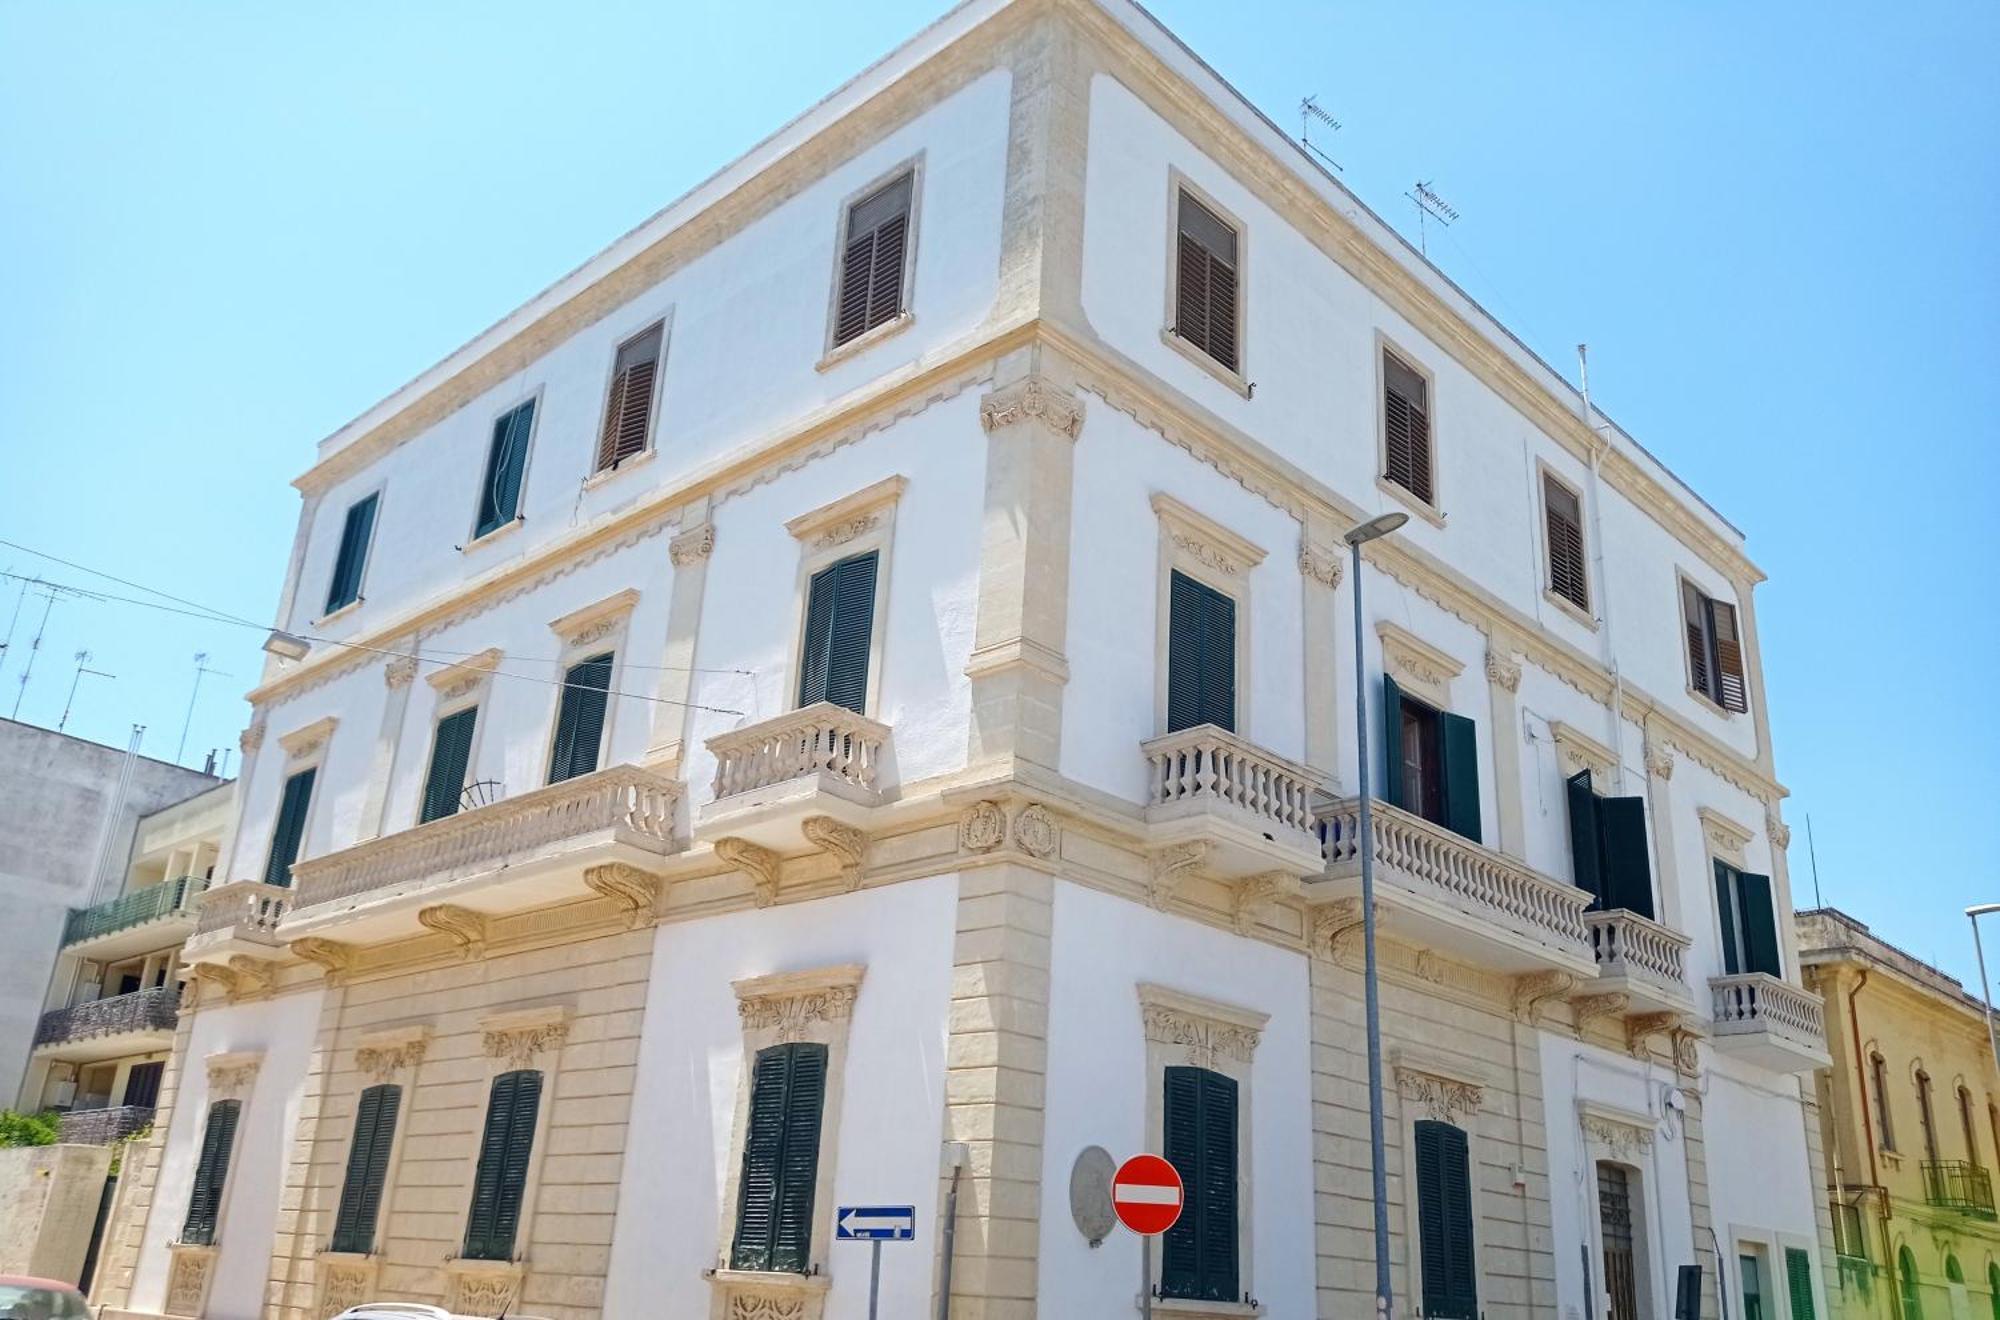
[1306,798,1598,980]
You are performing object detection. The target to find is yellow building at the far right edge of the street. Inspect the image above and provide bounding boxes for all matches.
[1798,908,2000,1320]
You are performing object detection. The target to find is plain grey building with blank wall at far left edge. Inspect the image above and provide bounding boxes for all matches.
[0,720,218,1106]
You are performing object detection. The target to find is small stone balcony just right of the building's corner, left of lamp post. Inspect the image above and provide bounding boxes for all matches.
[1138,724,1320,880]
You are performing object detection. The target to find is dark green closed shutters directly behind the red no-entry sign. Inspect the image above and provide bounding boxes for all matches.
[1160,1068,1242,1302]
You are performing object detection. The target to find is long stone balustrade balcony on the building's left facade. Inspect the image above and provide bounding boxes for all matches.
[284,766,680,942]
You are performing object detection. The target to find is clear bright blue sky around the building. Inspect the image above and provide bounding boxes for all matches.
[0,0,2000,982]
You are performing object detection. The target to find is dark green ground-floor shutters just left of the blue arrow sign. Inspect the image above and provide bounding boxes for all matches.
[730,1042,826,1274]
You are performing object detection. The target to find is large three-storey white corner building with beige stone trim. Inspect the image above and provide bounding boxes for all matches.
[98,0,1830,1320]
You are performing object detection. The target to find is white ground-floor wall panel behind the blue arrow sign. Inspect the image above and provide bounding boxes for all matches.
[604,874,958,1320]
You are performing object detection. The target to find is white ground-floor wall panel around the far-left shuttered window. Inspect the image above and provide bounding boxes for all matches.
[130,990,324,1320]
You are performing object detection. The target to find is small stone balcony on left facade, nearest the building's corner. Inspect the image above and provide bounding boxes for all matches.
[694,702,890,852]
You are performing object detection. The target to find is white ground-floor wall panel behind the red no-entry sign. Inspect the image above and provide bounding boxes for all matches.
[1040,880,1314,1316]
